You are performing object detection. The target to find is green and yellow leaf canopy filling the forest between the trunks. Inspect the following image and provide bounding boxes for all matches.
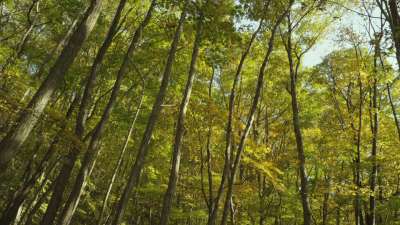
[0,0,400,224]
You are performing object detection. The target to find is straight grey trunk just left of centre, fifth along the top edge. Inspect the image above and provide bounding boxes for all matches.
[160,0,208,225]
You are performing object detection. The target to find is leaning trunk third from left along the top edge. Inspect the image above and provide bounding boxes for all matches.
[57,0,156,225]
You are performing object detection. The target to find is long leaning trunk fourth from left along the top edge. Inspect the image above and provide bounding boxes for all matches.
[112,1,189,225]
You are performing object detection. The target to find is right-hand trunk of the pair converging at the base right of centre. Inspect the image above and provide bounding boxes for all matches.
[221,4,294,225]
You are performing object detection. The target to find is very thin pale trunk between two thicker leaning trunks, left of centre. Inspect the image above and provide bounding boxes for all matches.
[97,83,144,225]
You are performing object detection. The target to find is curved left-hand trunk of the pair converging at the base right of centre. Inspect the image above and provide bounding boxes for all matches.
[208,4,271,225]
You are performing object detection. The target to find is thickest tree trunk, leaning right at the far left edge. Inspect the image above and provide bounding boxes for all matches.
[0,0,104,171]
